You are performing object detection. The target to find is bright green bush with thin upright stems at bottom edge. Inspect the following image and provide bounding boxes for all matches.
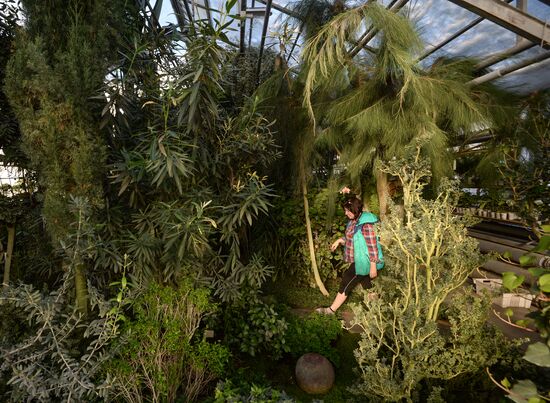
[106,282,230,402]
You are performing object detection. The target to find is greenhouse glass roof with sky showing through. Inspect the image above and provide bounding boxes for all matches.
[156,0,550,94]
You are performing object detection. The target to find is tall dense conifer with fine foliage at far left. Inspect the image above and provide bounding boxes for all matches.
[6,0,138,313]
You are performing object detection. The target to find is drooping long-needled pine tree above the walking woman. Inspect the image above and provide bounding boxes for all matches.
[303,2,496,216]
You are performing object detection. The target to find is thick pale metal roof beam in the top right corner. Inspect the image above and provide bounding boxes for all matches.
[449,0,550,49]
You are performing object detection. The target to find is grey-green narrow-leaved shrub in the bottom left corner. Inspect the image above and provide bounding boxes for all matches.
[0,272,127,402]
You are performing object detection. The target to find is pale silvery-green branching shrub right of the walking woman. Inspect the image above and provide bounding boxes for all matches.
[353,148,516,401]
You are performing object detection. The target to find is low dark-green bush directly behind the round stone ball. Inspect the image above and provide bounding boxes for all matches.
[285,314,342,367]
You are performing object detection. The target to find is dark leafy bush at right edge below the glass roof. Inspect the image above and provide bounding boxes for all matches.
[476,91,550,236]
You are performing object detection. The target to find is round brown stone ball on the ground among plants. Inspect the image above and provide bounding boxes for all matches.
[296,353,334,395]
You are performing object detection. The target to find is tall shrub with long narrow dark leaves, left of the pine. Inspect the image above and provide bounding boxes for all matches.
[95,15,278,301]
